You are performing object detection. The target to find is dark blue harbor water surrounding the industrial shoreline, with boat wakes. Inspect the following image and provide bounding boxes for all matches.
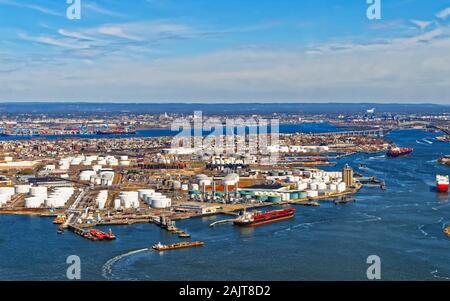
[0,125,450,280]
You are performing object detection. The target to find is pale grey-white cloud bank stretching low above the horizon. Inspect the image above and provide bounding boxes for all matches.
[0,28,450,103]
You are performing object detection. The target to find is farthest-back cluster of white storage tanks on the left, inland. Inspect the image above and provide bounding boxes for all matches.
[58,155,130,170]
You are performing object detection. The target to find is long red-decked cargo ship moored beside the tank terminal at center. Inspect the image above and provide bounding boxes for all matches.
[233,208,295,227]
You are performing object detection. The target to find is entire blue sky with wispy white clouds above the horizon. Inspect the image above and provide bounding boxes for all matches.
[0,0,450,104]
